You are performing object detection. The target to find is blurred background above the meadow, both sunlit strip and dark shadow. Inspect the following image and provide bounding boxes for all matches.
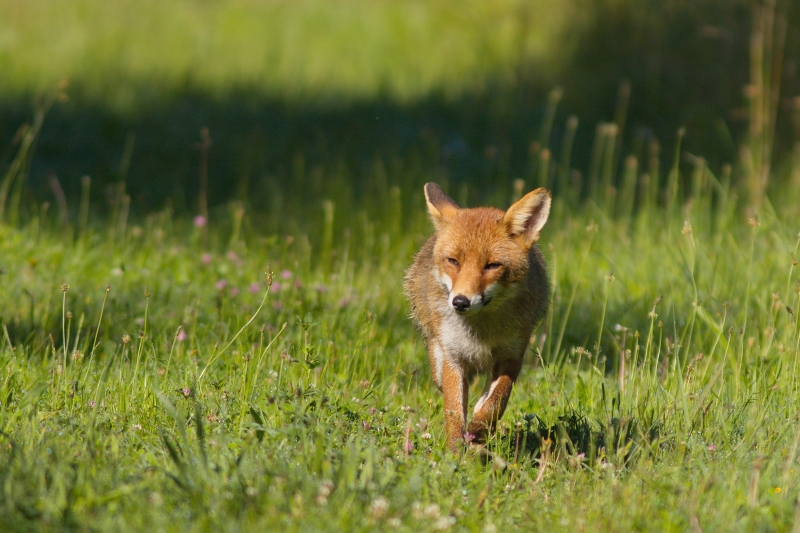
[0,0,800,220]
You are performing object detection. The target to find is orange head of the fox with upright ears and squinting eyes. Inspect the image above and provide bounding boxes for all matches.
[425,183,550,315]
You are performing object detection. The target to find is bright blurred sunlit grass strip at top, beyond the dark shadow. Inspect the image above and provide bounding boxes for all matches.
[0,0,575,107]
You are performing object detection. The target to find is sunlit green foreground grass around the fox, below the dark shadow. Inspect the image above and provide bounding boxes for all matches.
[0,164,800,531]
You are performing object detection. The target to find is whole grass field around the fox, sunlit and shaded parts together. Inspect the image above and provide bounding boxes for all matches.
[0,0,800,533]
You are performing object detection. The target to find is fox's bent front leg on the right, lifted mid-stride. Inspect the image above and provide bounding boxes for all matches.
[467,357,522,444]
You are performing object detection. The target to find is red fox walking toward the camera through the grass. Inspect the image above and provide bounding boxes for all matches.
[405,183,550,451]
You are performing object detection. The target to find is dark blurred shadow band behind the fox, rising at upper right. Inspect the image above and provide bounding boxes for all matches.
[0,0,780,229]
